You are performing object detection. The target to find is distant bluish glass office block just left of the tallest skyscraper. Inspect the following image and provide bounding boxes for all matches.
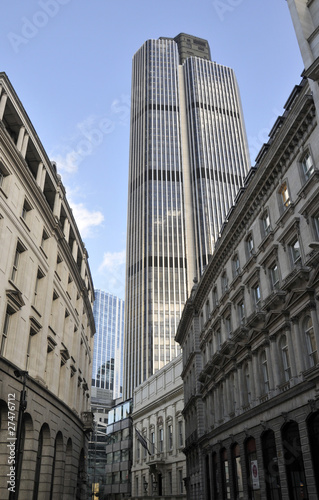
[92,290,124,401]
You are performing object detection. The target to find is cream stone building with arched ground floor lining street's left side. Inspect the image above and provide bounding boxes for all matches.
[0,73,95,500]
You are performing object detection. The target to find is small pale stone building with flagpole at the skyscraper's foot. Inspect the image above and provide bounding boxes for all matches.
[131,355,186,500]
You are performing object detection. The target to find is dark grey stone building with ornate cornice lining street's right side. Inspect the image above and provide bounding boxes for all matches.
[176,75,319,500]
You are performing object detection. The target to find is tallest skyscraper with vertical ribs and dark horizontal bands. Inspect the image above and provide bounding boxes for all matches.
[124,34,249,398]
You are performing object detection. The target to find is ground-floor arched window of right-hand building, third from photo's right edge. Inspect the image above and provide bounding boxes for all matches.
[261,429,282,500]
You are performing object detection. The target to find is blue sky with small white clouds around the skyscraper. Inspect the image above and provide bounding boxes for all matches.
[0,0,303,298]
